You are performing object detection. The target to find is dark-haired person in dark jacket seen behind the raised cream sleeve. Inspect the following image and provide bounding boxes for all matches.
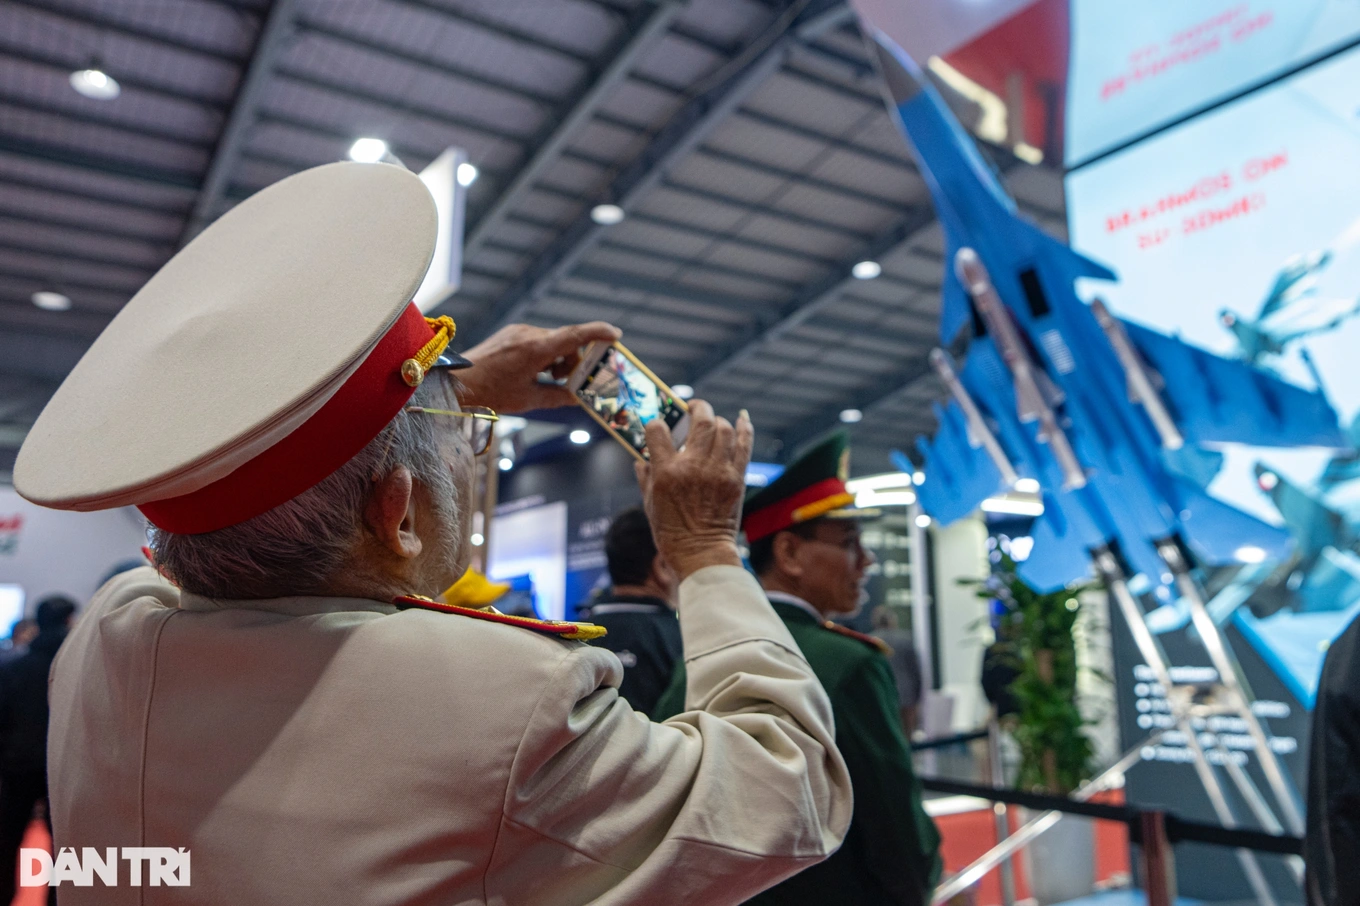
[590,507,681,714]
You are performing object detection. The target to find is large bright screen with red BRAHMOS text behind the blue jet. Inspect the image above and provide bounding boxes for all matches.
[1068,44,1360,709]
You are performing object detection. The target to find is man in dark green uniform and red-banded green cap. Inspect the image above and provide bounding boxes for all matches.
[654,434,940,906]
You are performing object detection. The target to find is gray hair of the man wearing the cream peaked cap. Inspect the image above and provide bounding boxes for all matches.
[150,370,460,599]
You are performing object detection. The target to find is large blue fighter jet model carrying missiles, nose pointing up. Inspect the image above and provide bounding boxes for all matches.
[869,34,1345,590]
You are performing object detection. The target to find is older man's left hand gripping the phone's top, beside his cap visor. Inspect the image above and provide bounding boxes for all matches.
[457,321,622,415]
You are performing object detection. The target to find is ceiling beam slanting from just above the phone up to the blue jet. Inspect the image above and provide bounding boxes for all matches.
[684,207,936,388]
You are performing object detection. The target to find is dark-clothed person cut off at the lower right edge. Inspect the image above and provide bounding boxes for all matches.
[1303,609,1360,906]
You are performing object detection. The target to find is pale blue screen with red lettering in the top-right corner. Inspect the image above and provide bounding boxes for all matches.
[1066,0,1360,166]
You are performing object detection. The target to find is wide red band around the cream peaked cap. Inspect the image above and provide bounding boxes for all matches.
[137,303,434,535]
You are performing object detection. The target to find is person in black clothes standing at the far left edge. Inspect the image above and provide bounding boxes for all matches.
[0,594,76,903]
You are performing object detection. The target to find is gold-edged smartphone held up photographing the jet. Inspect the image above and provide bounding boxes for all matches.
[567,343,690,461]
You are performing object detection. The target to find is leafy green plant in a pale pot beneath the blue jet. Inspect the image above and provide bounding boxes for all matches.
[960,551,1095,903]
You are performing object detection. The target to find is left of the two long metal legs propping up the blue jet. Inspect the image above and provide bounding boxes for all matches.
[1093,548,1278,906]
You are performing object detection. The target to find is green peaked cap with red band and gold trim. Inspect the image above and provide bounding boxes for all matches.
[741,431,854,541]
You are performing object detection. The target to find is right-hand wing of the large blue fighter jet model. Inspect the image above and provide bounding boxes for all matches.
[1123,321,1346,448]
